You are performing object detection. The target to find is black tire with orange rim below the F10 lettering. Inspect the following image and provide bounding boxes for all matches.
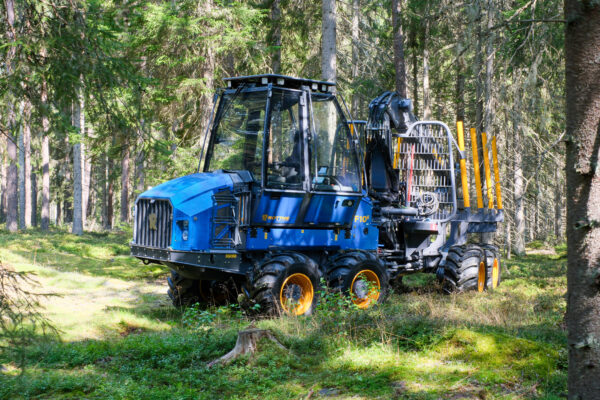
[327,251,389,308]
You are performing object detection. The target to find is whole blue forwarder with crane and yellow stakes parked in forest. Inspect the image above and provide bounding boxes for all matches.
[131,75,503,315]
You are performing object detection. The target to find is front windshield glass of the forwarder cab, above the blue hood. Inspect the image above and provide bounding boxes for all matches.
[205,90,267,181]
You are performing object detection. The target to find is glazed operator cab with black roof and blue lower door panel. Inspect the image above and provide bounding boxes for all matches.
[203,75,363,228]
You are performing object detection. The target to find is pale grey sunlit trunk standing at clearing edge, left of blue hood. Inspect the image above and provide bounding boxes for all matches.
[72,83,85,235]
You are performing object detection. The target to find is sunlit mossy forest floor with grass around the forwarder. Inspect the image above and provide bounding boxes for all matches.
[0,230,567,400]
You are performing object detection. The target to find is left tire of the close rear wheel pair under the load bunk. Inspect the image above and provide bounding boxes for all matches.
[442,245,487,293]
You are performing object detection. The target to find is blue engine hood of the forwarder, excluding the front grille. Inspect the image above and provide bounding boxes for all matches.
[139,172,233,250]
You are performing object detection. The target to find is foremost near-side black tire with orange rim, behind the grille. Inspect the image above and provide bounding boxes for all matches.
[250,252,321,315]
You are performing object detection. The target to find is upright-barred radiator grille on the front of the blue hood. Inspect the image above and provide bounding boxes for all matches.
[135,199,173,248]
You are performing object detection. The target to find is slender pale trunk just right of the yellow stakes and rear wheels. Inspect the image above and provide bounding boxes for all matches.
[513,90,525,255]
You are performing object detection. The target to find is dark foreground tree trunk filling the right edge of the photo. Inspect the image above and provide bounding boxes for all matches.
[565,0,600,400]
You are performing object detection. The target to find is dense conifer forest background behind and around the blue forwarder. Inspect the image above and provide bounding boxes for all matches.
[0,0,565,253]
